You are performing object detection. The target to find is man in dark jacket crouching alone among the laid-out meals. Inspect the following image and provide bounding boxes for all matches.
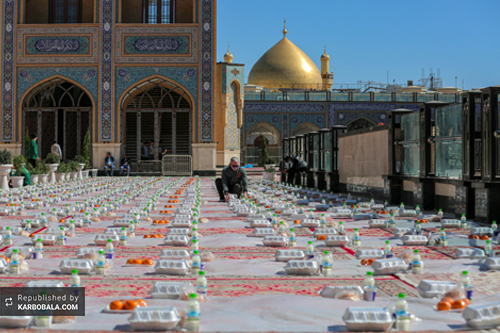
[215,156,248,202]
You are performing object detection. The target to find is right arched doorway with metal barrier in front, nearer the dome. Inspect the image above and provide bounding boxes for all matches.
[121,77,192,161]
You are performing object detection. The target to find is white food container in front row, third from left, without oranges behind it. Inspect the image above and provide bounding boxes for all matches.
[342,307,393,331]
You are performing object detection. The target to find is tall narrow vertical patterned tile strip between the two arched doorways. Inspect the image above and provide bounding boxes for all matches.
[100,0,114,142]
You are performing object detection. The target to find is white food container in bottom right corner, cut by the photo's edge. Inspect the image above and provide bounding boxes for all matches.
[462,302,500,329]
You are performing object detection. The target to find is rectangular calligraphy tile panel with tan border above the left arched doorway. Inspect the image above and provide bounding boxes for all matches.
[16,26,99,64]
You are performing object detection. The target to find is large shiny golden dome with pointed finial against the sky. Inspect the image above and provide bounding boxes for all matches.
[248,27,322,89]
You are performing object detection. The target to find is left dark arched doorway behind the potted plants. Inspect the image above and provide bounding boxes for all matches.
[22,78,93,160]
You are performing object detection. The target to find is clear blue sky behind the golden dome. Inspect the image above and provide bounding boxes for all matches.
[217,0,500,89]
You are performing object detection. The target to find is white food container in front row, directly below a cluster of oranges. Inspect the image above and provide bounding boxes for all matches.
[128,306,181,331]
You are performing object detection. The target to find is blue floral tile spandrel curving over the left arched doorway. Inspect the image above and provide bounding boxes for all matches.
[16,66,98,105]
